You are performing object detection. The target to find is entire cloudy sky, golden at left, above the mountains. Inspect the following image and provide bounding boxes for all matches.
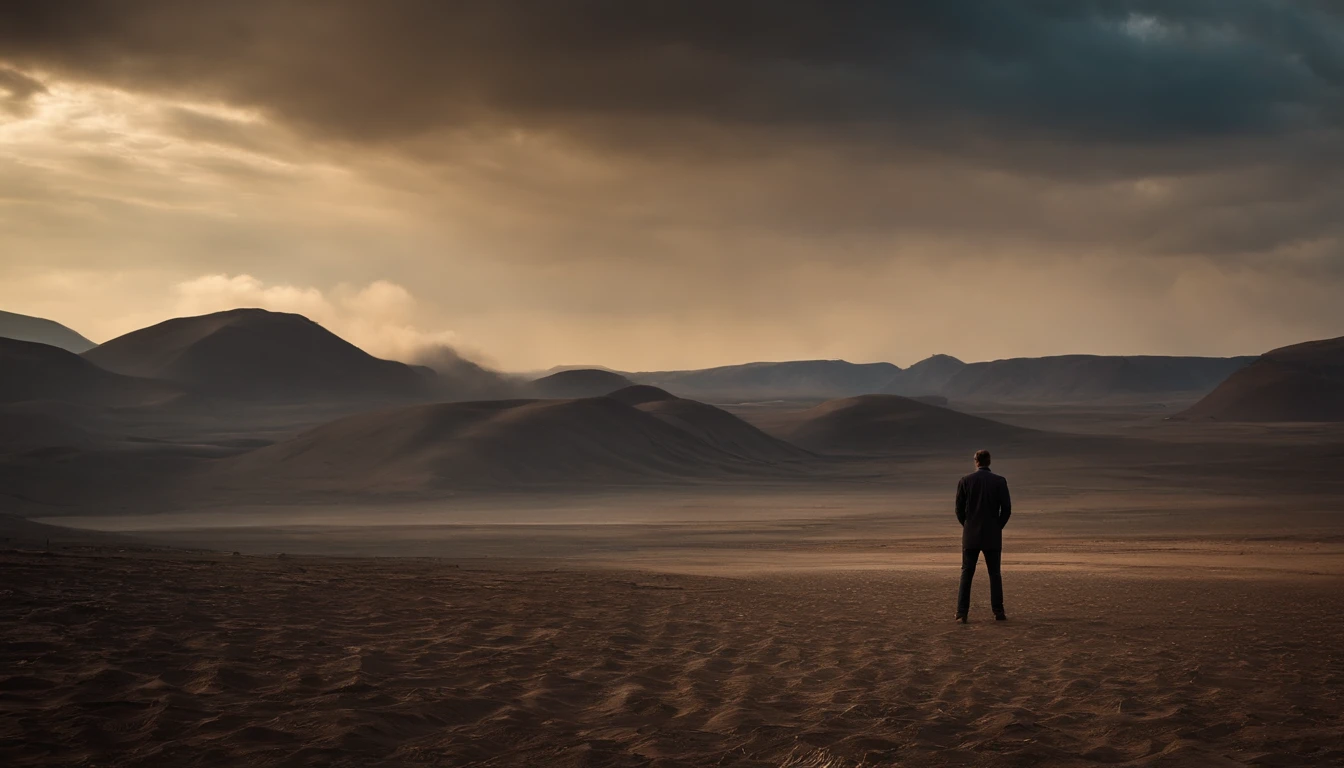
[0,0,1344,370]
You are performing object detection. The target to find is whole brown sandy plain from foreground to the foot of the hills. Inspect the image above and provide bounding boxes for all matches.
[0,412,1344,768]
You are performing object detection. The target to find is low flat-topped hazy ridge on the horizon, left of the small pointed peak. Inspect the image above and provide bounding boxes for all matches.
[628,360,900,399]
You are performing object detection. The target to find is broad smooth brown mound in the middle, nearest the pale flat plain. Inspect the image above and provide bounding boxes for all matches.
[208,397,795,492]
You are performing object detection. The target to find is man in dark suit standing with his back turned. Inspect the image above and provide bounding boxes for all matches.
[957,451,1012,624]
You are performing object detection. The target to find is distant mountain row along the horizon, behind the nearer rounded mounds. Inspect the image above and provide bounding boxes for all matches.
[0,309,1300,414]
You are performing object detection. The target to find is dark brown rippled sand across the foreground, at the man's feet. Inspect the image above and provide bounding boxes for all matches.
[0,542,1344,767]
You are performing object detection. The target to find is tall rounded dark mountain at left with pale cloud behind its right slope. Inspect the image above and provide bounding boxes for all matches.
[83,309,433,401]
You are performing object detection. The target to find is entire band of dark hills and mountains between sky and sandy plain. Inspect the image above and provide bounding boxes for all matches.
[0,303,1344,507]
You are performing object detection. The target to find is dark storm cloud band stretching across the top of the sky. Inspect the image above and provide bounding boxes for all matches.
[0,0,1344,144]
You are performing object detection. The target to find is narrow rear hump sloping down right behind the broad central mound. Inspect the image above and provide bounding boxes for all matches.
[607,385,808,463]
